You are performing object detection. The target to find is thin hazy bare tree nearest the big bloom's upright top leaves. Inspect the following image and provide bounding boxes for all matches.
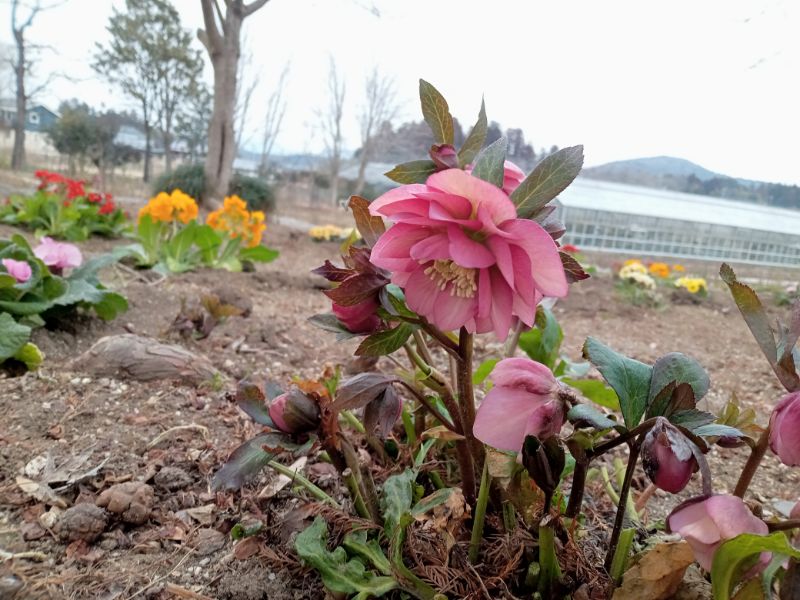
[355,66,399,194]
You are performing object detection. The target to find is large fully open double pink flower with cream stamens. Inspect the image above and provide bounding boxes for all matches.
[370,169,567,339]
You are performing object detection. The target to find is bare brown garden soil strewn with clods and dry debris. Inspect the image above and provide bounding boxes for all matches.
[0,217,800,600]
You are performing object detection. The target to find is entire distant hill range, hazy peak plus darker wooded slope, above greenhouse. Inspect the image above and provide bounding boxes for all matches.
[581,156,800,209]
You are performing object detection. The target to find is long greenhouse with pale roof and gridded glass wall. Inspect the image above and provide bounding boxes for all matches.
[556,178,800,267]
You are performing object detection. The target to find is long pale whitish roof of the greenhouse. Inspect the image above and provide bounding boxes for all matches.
[558,177,800,235]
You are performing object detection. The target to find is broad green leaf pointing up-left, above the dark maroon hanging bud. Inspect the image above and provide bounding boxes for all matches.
[583,337,653,429]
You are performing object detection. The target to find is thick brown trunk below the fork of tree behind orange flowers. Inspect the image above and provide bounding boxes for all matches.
[203,21,242,205]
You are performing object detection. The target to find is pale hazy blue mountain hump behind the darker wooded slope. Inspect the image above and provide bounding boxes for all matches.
[581,156,726,183]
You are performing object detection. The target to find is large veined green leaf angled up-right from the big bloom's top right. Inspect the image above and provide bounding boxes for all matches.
[511,146,583,219]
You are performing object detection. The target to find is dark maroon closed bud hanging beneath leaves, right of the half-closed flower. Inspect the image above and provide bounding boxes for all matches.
[642,417,698,494]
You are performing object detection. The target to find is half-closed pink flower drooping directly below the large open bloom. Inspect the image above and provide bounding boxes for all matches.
[472,358,564,452]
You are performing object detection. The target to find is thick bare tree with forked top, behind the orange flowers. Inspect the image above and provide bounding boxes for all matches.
[197,0,268,201]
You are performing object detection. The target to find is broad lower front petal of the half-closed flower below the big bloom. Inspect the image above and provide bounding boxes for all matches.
[472,387,538,452]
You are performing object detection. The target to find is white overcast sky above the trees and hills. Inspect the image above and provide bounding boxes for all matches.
[0,0,800,183]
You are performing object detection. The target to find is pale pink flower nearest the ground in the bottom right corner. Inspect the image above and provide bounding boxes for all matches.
[667,495,769,571]
